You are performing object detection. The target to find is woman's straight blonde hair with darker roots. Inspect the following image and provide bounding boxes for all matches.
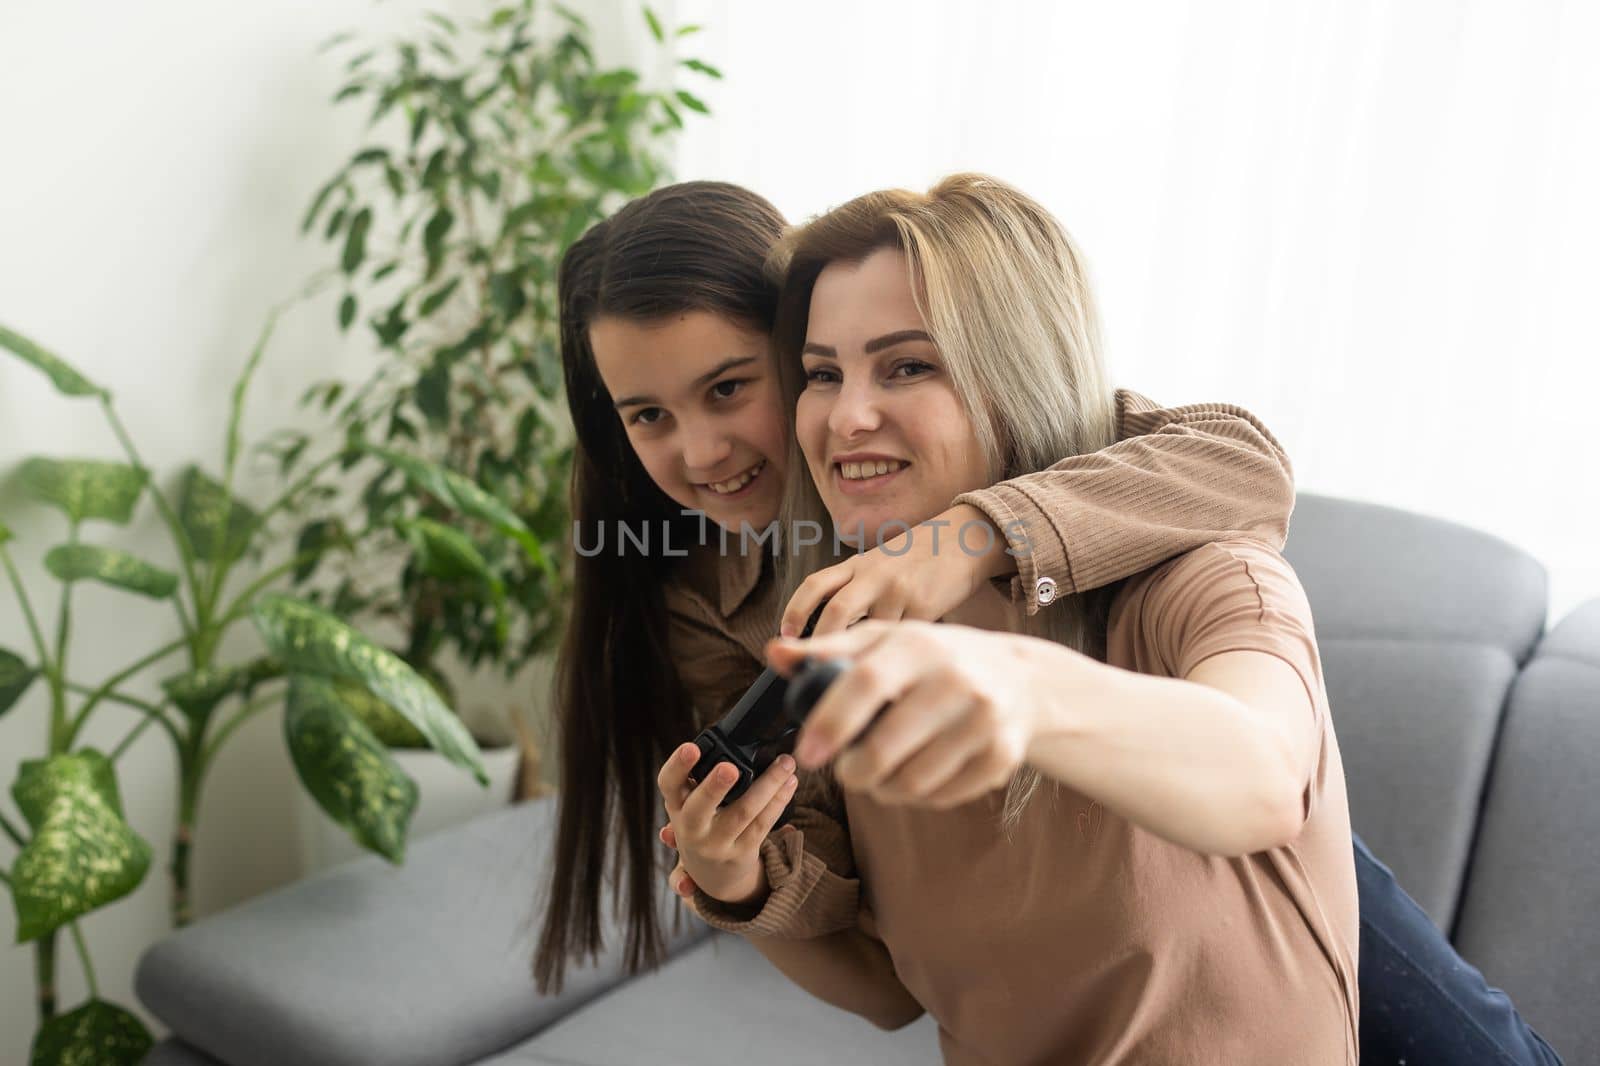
[770,174,1117,829]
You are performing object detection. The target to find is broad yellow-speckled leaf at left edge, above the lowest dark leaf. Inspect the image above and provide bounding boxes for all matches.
[11,747,150,943]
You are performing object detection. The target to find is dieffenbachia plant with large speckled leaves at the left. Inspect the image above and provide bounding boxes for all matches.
[0,320,483,1063]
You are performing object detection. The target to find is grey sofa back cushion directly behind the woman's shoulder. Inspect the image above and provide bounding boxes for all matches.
[1285,493,1547,930]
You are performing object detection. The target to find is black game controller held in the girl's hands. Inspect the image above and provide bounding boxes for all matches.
[690,607,848,807]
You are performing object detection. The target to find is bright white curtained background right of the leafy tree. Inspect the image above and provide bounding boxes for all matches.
[678,0,1600,616]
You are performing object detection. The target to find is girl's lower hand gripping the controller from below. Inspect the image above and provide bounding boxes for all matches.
[656,744,798,904]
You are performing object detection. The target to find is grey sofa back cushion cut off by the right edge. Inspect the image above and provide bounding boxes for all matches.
[1456,600,1600,1063]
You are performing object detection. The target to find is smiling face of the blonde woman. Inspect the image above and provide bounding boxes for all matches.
[795,248,990,547]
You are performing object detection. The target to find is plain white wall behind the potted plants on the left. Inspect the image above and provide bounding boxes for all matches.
[0,0,642,1064]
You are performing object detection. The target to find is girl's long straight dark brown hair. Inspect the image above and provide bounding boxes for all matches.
[533,181,784,994]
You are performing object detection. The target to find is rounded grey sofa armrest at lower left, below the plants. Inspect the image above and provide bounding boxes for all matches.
[134,799,710,1066]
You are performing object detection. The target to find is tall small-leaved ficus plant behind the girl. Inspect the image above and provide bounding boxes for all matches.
[272,0,720,781]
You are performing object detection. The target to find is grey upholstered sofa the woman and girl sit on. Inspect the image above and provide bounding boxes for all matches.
[138,495,1600,1066]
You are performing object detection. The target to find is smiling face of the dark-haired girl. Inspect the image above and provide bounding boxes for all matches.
[589,311,787,531]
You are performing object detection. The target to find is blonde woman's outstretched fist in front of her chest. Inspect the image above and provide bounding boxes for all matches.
[766,621,1049,808]
